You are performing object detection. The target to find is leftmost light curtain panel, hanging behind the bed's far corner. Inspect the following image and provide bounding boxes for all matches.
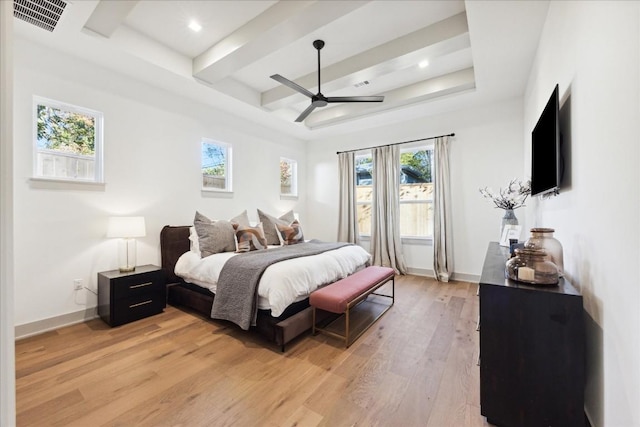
[338,151,360,244]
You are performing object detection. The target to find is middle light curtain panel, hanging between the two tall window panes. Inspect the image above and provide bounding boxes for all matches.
[371,145,407,274]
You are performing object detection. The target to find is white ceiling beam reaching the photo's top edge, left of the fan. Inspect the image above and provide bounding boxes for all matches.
[193,1,368,83]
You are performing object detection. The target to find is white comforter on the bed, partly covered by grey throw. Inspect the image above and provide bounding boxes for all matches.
[175,245,370,317]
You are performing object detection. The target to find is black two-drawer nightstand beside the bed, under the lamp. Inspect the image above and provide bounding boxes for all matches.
[98,265,167,326]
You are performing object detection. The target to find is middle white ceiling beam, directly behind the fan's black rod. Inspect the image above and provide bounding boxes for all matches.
[262,12,470,110]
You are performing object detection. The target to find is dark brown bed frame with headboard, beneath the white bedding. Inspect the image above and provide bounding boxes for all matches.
[160,225,328,352]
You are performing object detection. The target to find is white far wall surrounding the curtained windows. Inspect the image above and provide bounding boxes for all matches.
[305,99,528,280]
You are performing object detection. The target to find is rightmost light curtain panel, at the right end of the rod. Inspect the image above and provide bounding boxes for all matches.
[433,136,453,282]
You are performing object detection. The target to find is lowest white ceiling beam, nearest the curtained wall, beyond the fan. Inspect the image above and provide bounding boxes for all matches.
[304,67,475,129]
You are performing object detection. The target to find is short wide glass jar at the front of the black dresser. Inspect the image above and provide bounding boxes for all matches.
[505,247,558,285]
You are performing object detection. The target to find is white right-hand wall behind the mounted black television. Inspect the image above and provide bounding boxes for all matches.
[524,1,640,427]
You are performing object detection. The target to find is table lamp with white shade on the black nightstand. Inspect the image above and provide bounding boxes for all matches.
[107,216,146,273]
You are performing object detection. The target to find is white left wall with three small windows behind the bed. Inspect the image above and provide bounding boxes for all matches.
[14,39,306,327]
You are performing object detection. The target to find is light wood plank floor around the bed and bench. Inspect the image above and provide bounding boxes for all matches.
[16,276,488,427]
